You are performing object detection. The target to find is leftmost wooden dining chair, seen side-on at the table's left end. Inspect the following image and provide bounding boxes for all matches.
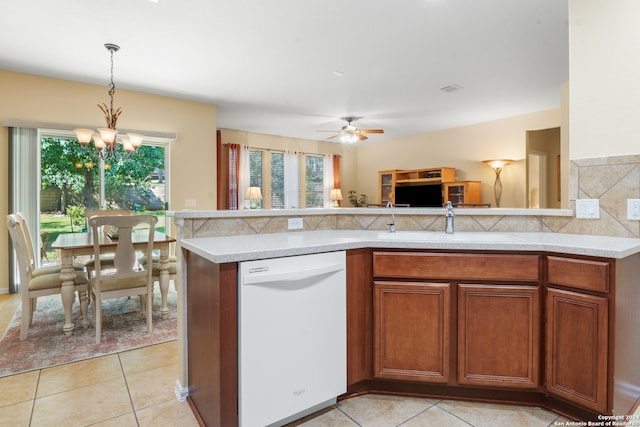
[7,214,88,340]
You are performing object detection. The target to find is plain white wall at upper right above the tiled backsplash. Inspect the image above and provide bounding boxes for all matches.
[569,0,640,160]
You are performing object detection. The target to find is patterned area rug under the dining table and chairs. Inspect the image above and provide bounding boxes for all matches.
[0,283,178,377]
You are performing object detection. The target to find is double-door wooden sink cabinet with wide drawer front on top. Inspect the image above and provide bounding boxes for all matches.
[373,251,541,389]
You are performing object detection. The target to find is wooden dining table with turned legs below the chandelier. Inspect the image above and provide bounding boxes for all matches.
[51,230,176,336]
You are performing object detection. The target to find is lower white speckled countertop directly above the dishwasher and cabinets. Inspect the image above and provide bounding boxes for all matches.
[181,230,640,263]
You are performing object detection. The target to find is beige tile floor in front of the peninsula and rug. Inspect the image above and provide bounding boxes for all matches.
[0,295,636,427]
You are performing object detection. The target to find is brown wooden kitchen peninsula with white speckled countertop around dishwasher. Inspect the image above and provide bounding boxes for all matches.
[173,209,640,425]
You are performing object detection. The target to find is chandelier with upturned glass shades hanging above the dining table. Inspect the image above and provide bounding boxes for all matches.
[73,43,144,160]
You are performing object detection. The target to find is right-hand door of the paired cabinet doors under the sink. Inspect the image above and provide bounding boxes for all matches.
[458,284,540,389]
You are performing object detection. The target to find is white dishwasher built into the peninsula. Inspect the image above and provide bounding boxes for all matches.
[238,251,347,427]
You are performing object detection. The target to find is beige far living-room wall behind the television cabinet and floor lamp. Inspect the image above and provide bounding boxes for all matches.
[352,109,562,208]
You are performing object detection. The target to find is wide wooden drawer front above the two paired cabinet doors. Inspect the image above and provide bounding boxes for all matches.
[373,252,540,282]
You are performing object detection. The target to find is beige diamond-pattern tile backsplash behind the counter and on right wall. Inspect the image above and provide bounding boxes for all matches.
[181,154,640,238]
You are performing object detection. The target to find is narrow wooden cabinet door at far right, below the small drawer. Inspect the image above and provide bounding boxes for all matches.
[546,289,609,413]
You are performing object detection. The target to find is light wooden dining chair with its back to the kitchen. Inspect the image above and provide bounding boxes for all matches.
[89,215,158,344]
